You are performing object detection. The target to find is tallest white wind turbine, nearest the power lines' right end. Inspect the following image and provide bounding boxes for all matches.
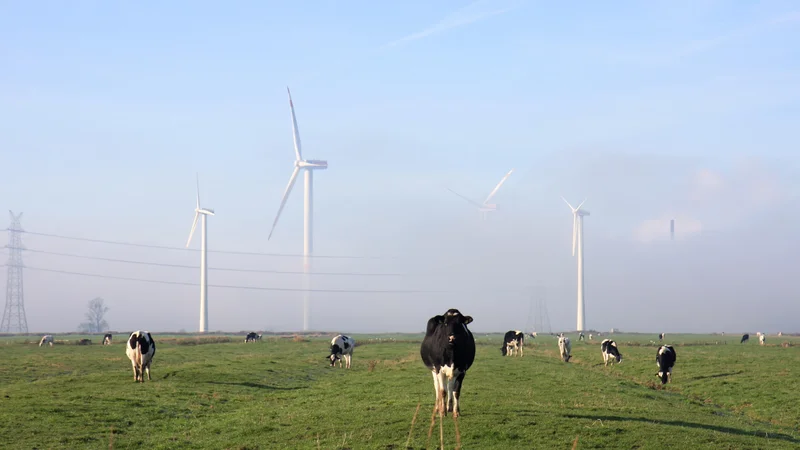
[267,87,328,331]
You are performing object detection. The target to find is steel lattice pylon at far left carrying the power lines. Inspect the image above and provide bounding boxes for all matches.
[0,211,28,333]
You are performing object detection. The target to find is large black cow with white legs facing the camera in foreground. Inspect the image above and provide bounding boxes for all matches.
[419,309,475,417]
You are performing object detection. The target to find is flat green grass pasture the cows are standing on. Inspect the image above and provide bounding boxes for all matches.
[0,334,800,449]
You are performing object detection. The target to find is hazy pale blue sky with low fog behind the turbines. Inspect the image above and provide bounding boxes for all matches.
[0,0,800,333]
